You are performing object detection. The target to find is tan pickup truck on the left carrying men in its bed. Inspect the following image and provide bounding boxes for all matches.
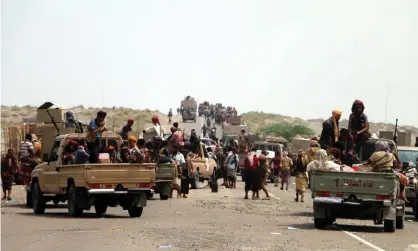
[27,133,156,217]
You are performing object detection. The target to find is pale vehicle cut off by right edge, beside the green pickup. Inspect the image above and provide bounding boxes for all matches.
[398,146,418,220]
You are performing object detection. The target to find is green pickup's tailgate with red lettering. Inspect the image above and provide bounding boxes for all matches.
[311,171,399,197]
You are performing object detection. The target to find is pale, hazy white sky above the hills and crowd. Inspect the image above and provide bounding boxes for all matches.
[1,0,418,126]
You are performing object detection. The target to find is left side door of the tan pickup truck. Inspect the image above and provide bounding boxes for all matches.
[40,140,61,193]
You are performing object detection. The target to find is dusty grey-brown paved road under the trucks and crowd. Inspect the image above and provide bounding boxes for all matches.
[1,178,418,251]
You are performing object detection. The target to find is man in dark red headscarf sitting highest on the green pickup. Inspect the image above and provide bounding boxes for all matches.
[348,100,371,153]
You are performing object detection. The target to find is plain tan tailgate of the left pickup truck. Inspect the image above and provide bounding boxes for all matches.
[86,163,156,188]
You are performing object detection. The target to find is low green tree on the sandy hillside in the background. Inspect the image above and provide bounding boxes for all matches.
[262,122,314,142]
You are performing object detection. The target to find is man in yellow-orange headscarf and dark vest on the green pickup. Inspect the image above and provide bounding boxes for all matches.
[319,109,342,150]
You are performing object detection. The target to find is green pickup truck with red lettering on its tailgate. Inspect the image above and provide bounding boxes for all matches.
[311,139,405,232]
